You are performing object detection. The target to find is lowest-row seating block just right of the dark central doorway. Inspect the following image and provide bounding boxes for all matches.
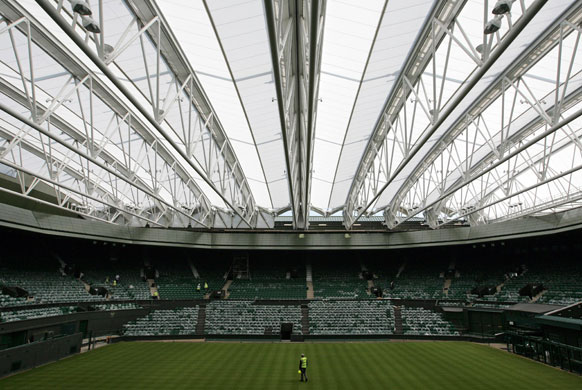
[309,300,394,335]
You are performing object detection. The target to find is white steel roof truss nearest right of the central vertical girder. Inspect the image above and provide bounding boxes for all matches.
[344,1,576,227]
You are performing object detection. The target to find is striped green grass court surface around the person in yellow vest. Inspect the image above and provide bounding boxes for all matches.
[0,342,582,390]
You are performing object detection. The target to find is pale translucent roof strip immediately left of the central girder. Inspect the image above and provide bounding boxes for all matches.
[207,0,289,208]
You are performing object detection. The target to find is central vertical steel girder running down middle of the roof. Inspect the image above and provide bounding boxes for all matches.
[265,0,326,229]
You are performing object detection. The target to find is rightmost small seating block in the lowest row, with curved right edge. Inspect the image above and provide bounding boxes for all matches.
[401,306,459,336]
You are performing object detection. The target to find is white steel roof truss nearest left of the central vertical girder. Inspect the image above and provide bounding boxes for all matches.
[37,0,264,227]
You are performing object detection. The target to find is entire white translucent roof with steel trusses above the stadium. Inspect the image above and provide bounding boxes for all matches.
[0,0,582,230]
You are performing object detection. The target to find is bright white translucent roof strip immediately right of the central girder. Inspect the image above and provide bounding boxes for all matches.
[311,0,385,210]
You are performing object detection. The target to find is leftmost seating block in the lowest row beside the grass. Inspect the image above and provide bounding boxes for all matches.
[123,306,198,336]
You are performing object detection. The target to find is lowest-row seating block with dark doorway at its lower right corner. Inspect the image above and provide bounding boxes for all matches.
[205,300,301,335]
